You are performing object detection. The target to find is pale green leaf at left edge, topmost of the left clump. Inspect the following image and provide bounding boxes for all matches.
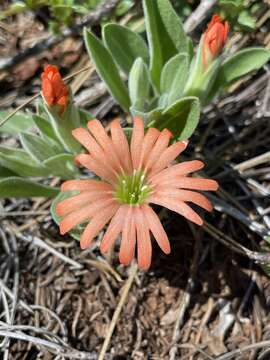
[0,111,34,135]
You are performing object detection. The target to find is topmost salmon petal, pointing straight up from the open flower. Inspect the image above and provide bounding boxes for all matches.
[130,117,144,170]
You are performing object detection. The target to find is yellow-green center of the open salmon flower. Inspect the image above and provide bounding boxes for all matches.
[114,170,151,205]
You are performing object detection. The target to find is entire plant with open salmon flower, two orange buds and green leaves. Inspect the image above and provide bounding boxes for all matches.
[0,0,270,269]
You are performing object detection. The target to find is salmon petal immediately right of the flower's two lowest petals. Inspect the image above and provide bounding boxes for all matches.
[142,204,171,254]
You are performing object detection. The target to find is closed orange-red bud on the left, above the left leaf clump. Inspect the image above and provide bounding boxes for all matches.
[41,65,69,112]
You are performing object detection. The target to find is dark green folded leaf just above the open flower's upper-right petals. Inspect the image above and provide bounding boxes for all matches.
[151,96,200,140]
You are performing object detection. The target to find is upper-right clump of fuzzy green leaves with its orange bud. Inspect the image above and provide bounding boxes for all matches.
[84,0,270,140]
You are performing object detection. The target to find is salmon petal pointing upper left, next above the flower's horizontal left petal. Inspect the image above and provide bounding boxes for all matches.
[75,154,117,183]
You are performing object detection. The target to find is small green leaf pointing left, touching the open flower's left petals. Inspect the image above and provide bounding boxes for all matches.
[43,154,79,180]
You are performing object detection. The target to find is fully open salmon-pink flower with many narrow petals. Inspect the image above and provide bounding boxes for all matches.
[56,118,218,269]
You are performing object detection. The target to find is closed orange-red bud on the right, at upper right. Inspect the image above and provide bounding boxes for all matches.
[203,14,229,68]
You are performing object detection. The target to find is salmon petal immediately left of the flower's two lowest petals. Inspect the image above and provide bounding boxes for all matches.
[100,205,128,253]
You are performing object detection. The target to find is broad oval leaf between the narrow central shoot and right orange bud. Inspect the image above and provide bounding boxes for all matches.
[160,53,189,105]
